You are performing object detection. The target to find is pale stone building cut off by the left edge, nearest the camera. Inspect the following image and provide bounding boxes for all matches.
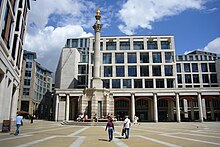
[0,0,30,124]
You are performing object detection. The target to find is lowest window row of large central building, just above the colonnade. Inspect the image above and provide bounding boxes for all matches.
[103,79,174,88]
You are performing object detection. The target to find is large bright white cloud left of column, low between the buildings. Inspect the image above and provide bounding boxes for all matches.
[25,25,92,72]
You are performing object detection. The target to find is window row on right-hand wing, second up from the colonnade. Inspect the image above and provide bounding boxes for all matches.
[176,63,216,73]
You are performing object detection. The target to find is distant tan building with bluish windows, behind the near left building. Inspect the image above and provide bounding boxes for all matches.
[18,50,53,119]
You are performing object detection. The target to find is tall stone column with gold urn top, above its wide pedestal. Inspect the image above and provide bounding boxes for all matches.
[92,8,103,88]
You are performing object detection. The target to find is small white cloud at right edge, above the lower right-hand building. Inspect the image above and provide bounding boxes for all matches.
[204,37,220,54]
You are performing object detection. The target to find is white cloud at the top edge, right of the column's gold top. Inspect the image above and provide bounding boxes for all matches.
[118,0,207,35]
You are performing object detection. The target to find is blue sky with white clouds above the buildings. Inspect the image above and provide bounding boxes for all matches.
[25,0,220,72]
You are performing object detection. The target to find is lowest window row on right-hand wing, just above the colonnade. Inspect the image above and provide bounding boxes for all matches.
[177,74,218,84]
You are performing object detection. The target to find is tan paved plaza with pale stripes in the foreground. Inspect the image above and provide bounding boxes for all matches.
[0,120,220,147]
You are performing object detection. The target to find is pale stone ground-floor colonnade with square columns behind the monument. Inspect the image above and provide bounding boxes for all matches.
[55,92,219,122]
